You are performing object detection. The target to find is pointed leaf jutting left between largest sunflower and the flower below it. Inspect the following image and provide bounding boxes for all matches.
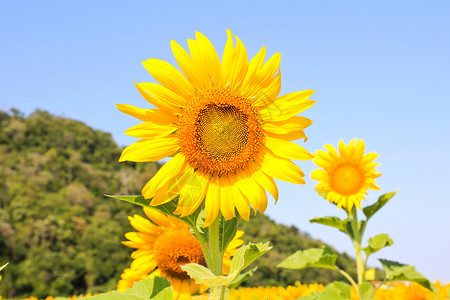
[105,195,201,227]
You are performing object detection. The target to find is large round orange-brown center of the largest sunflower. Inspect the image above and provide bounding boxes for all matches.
[177,88,263,176]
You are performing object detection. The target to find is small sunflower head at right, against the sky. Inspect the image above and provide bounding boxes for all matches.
[311,139,381,212]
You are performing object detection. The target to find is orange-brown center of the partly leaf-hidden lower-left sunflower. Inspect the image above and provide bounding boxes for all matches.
[154,228,206,279]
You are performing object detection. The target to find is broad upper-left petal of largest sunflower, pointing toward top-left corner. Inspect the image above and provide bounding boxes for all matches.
[142,58,195,99]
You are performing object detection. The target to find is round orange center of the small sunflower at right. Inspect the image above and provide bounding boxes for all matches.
[331,164,363,196]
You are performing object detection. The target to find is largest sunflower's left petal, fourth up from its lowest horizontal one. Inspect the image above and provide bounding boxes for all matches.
[135,82,186,113]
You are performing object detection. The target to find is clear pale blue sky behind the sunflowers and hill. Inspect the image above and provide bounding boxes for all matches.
[0,1,450,282]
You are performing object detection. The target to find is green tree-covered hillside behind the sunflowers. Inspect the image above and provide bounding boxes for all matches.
[0,110,355,298]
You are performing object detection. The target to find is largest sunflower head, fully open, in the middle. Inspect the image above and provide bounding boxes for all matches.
[117,30,315,226]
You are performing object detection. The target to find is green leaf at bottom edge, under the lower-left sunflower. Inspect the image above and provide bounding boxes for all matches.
[85,276,173,300]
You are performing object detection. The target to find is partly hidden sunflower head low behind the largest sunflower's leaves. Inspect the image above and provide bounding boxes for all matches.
[117,207,244,299]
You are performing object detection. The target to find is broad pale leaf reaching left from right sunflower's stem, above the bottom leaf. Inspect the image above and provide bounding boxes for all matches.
[277,247,337,270]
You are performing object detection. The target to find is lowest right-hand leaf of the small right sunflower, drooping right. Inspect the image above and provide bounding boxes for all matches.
[380,259,437,292]
